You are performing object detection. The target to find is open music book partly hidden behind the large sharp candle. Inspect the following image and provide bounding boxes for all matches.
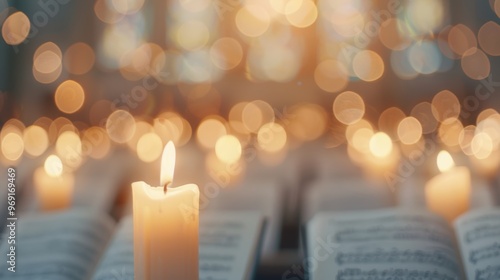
[0,210,264,280]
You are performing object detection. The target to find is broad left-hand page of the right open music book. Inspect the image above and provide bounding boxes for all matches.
[305,208,463,280]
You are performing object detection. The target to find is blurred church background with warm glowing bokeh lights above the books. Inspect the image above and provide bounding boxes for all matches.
[0,0,500,276]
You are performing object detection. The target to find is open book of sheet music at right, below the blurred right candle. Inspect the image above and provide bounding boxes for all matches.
[302,208,500,280]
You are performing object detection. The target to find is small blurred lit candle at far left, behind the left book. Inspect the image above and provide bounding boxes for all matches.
[33,155,74,211]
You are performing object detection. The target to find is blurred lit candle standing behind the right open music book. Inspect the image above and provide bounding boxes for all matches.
[425,151,471,222]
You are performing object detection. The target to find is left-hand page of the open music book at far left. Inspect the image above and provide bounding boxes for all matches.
[0,210,114,280]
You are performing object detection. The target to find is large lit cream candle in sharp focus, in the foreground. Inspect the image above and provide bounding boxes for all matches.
[132,142,199,280]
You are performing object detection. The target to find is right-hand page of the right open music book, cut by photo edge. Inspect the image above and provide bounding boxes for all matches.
[455,208,500,280]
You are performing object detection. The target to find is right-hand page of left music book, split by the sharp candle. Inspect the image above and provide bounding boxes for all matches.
[93,212,263,280]
